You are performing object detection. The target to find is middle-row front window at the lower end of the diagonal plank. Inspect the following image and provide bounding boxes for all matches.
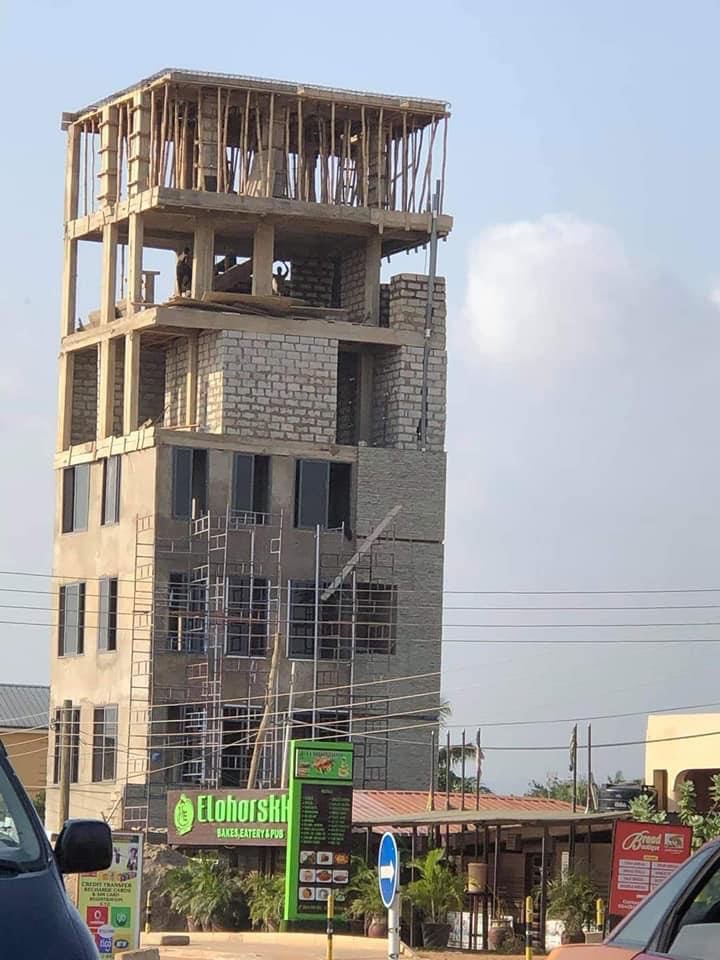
[288,580,352,660]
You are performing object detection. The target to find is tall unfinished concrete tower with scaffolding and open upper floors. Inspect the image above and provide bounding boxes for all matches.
[48,70,452,828]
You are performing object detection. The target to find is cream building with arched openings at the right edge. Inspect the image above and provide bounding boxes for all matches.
[645,713,720,813]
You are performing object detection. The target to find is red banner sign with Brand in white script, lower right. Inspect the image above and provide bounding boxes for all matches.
[608,820,692,917]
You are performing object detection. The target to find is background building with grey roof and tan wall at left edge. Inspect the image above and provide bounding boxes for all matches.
[0,683,50,798]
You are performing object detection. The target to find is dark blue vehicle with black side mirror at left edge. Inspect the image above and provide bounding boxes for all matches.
[0,740,112,960]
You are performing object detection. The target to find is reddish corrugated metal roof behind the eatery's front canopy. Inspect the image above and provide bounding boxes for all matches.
[353,790,573,826]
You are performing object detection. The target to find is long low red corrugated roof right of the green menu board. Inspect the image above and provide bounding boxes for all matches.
[353,790,572,821]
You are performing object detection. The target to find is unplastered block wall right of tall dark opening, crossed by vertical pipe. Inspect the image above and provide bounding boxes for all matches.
[372,346,447,450]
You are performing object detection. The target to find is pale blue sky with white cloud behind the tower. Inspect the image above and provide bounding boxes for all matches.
[0,0,720,789]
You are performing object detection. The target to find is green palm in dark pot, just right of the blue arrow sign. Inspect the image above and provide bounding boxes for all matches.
[407,848,464,949]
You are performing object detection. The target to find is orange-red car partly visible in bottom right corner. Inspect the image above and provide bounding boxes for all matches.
[550,840,720,960]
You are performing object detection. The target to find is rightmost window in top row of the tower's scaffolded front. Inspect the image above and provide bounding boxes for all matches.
[295,460,351,535]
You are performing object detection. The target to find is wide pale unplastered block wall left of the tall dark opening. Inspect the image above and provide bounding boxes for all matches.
[198,331,337,443]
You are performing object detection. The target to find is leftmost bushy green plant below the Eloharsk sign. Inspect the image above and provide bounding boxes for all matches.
[165,857,242,930]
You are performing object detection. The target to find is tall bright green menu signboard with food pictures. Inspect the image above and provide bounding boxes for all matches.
[285,740,353,920]
